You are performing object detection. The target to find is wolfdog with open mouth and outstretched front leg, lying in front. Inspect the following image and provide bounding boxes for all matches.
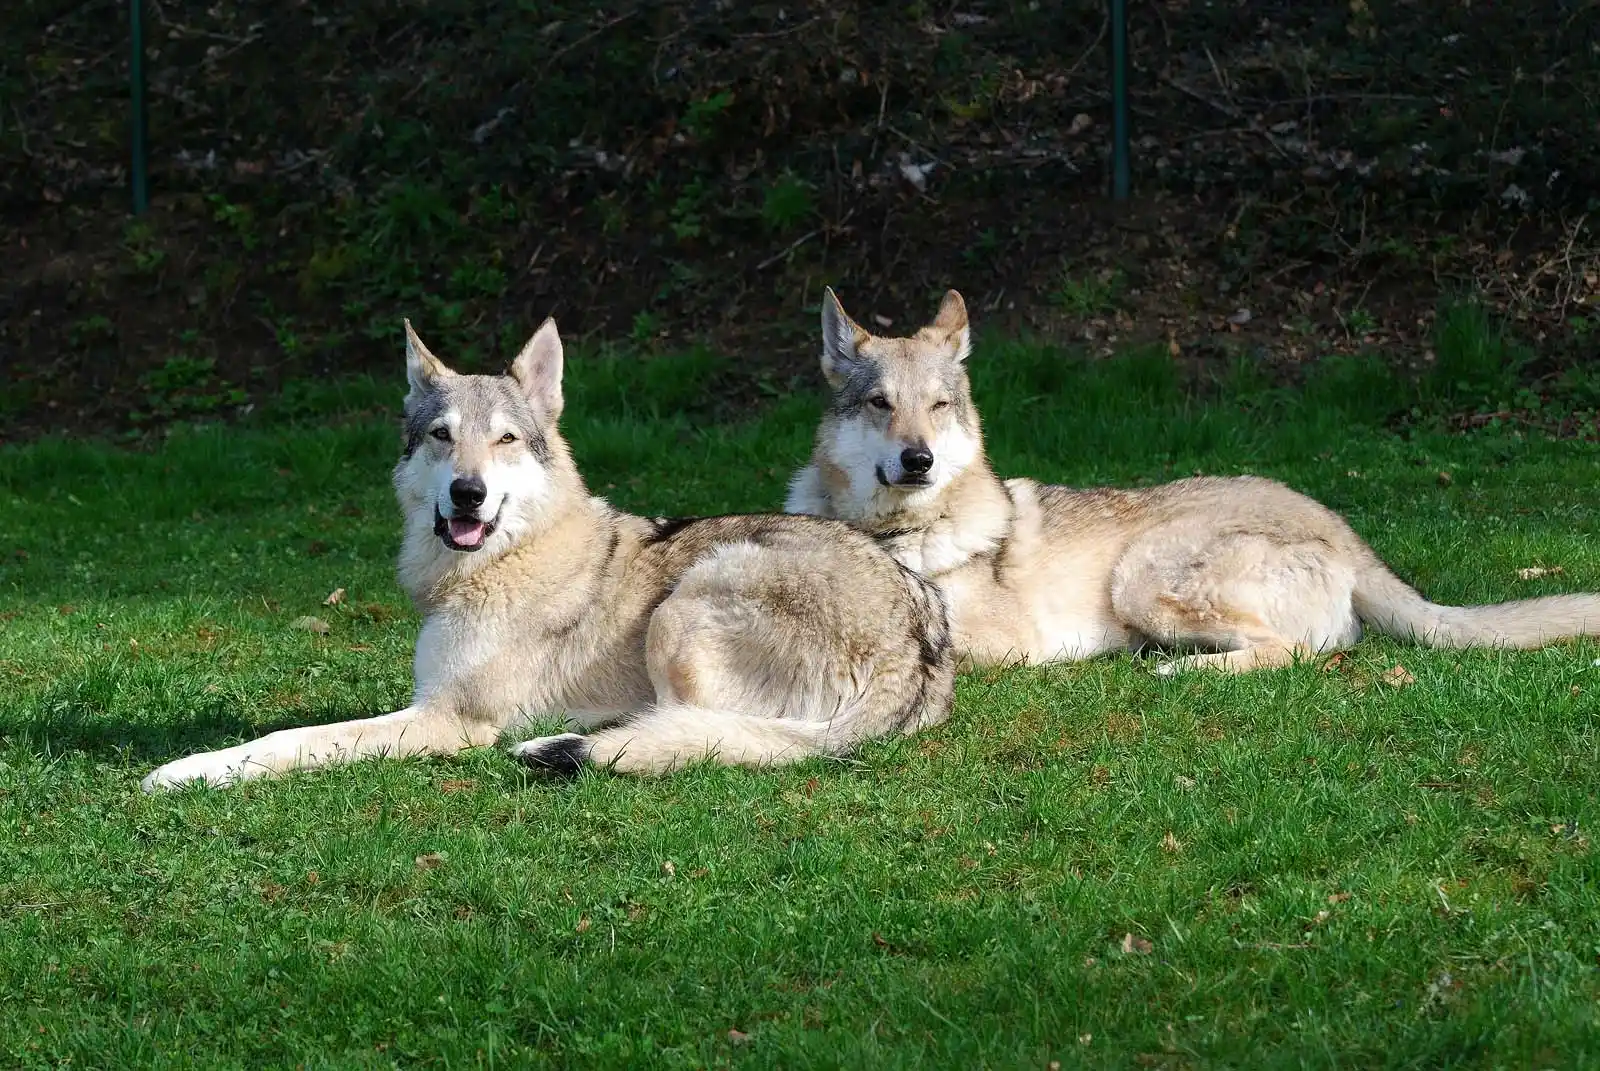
[144,320,955,791]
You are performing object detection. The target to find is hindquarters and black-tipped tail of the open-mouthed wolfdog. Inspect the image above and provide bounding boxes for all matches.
[514,538,954,773]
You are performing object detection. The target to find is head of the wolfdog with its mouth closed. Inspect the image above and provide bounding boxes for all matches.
[821,290,982,499]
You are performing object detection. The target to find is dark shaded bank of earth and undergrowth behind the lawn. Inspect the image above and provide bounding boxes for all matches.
[0,0,1600,439]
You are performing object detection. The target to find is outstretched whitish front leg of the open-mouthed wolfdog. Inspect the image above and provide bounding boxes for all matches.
[141,706,501,792]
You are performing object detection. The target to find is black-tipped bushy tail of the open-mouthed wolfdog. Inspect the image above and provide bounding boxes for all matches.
[512,703,858,775]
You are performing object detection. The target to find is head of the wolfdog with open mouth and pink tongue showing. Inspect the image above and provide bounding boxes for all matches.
[394,320,574,554]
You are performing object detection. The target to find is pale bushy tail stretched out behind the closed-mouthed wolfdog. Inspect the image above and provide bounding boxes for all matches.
[1355,559,1600,647]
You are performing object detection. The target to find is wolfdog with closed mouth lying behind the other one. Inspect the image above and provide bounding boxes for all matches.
[784,290,1600,672]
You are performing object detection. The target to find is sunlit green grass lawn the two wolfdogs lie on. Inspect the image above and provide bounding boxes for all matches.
[0,339,1600,1069]
